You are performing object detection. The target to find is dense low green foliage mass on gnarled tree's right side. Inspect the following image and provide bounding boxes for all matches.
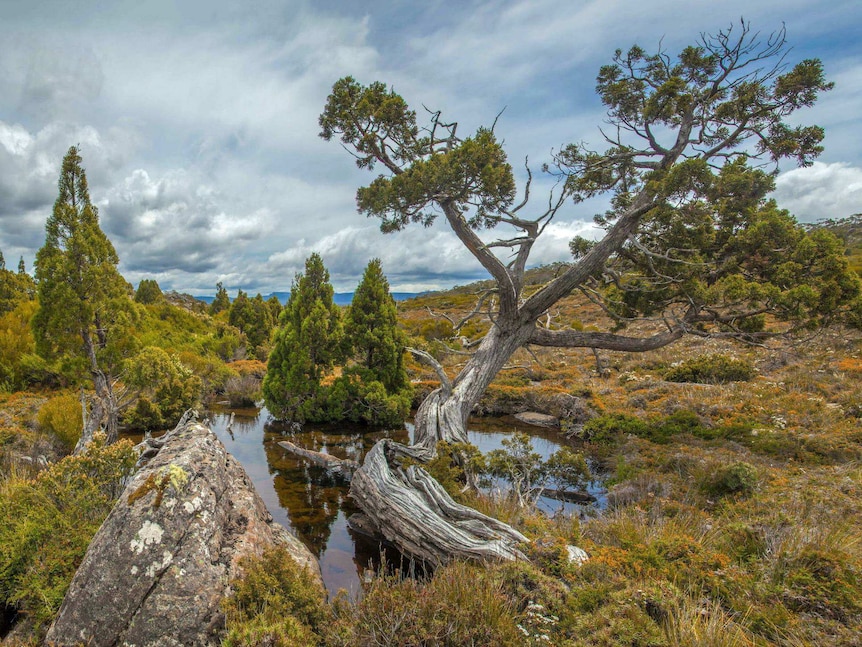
[592,160,862,339]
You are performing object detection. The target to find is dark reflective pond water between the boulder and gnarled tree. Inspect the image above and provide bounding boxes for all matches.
[209,409,601,596]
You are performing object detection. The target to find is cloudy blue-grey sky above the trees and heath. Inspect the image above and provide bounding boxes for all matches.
[0,0,862,294]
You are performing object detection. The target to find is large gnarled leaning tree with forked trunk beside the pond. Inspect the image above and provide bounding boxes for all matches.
[320,23,859,554]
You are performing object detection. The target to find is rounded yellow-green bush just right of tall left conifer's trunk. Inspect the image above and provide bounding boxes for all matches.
[124,346,201,430]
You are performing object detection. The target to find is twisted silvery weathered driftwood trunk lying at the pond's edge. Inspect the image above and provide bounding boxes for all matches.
[350,440,529,564]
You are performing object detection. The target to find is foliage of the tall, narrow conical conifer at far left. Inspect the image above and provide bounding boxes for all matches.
[32,146,134,388]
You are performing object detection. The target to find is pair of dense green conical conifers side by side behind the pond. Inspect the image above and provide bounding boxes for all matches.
[263,254,411,425]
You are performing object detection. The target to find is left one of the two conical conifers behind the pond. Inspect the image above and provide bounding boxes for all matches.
[263,254,342,421]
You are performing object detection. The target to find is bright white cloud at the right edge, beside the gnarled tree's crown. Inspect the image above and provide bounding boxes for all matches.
[775,162,862,222]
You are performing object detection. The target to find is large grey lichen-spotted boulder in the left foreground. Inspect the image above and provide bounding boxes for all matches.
[46,422,320,647]
